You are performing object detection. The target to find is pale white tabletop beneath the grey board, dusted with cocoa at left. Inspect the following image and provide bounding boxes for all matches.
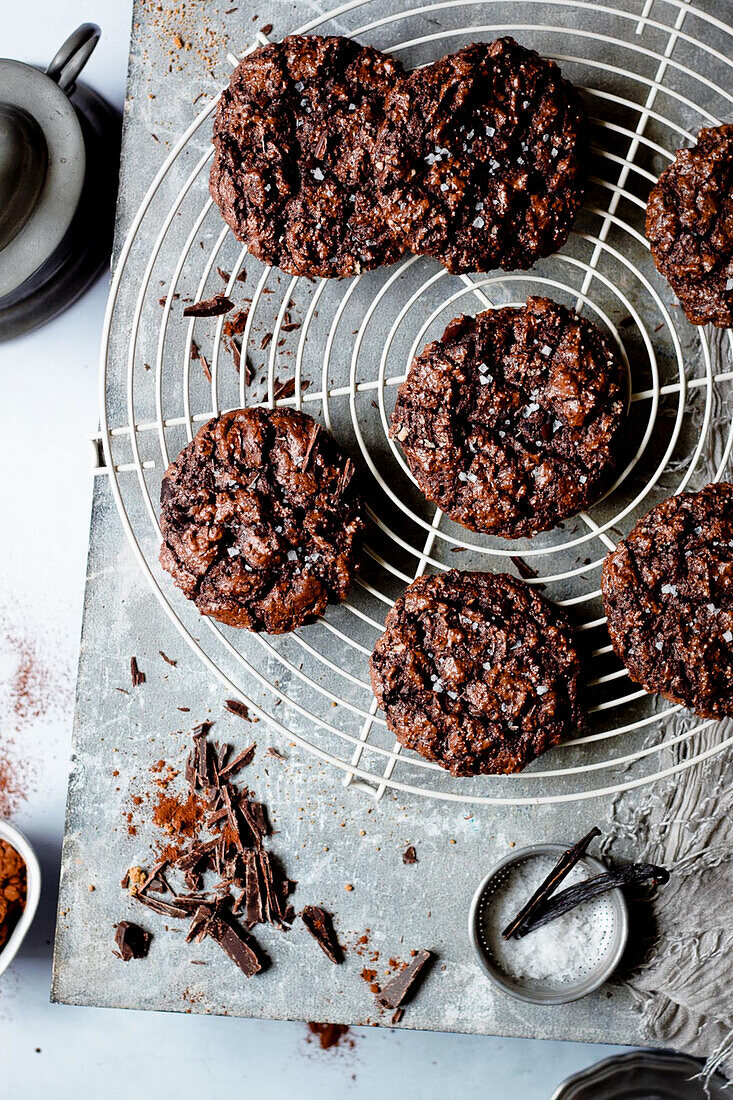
[0,0,622,1100]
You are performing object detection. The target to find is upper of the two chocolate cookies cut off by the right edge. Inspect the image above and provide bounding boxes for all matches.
[646,125,733,328]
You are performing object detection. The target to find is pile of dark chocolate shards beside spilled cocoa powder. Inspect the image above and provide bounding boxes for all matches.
[118,722,299,977]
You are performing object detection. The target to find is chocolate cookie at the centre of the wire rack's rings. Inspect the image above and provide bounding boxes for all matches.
[391,298,626,538]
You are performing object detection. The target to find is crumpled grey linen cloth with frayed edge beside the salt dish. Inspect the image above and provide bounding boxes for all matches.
[603,330,733,1078]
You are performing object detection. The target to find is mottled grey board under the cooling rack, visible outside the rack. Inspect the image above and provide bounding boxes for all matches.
[53,0,726,1044]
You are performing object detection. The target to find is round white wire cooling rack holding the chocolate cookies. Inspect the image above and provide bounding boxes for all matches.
[100,0,733,805]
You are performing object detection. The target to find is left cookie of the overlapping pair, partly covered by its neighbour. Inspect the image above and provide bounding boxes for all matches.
[209,34,404,277]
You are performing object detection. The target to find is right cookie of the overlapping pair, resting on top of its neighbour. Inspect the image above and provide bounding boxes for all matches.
[376,37,586,273]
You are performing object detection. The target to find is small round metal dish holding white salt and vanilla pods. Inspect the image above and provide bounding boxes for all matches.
[469,844,628,1004]
